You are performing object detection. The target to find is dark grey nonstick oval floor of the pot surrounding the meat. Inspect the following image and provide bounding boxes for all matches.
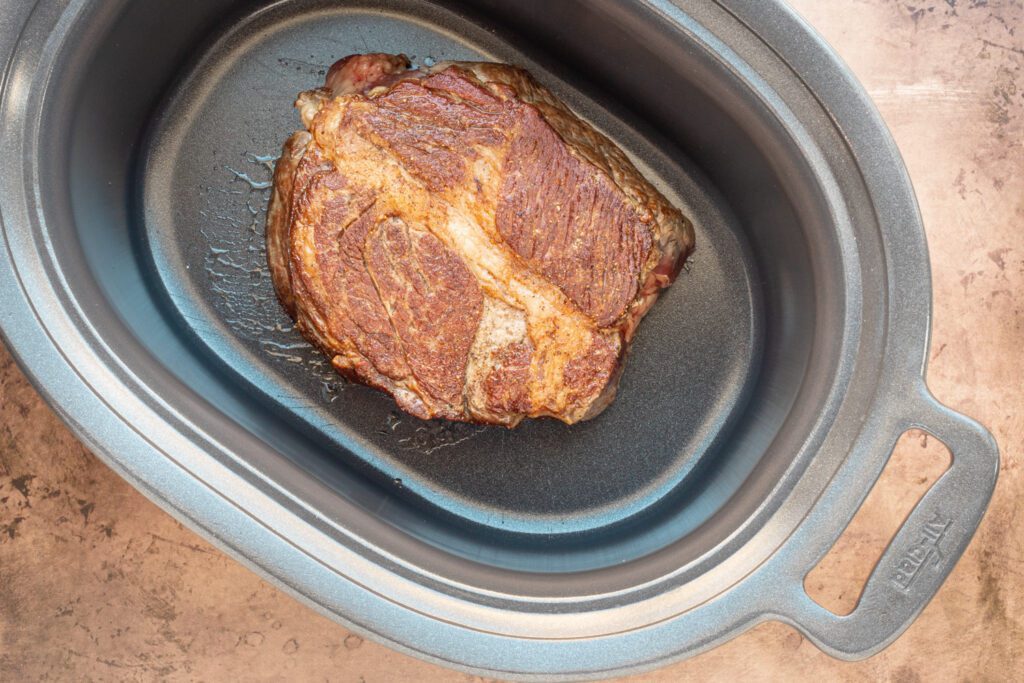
[135,2,761,548]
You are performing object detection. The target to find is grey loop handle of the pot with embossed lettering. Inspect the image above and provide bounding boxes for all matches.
[785,387,999,659]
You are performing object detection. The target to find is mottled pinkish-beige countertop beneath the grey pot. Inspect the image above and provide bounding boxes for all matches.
[0,0,1024,683]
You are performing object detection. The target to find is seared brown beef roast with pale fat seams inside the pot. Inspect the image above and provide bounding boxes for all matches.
[266,54,693,427]
